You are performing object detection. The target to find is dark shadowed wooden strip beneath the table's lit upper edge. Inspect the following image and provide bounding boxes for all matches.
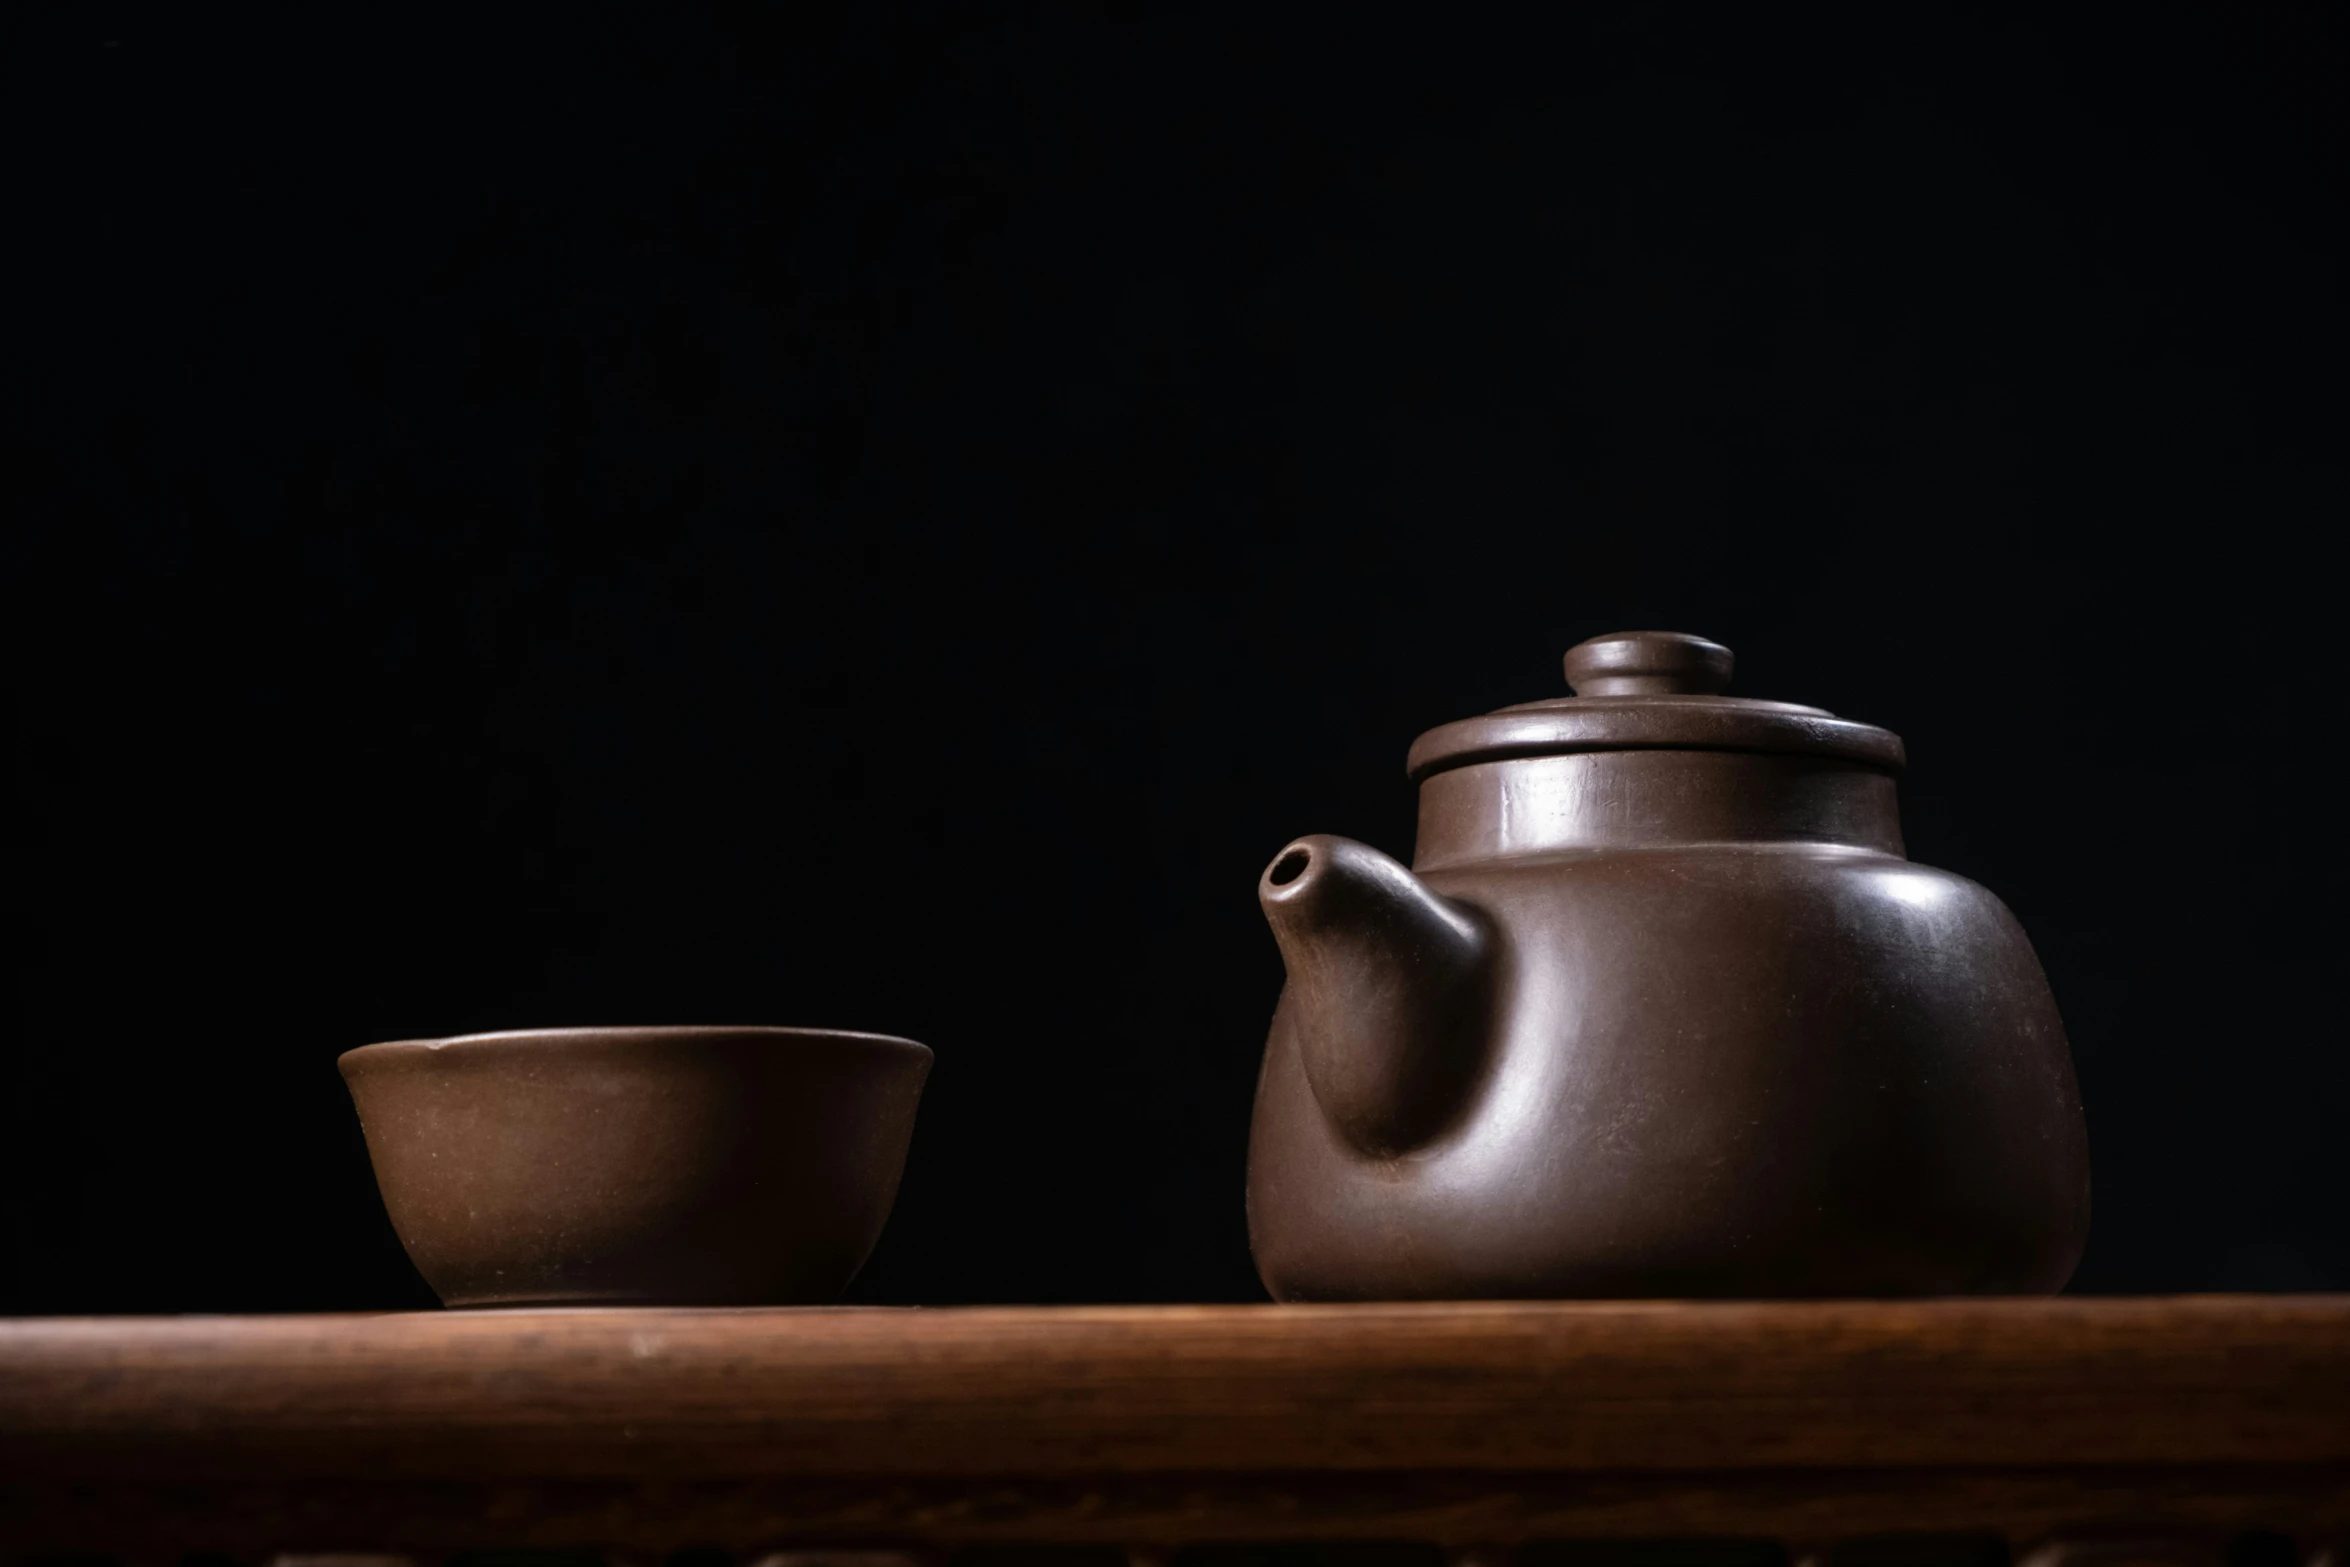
[0,1468,2350,1558]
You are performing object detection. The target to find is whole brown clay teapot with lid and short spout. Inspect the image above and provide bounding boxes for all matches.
[1248,632,2089,1299]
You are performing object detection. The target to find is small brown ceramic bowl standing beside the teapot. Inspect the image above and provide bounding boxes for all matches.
[341,1029,931,1306]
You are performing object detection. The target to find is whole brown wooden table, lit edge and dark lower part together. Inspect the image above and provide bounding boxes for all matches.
[0,1297,2350,1562]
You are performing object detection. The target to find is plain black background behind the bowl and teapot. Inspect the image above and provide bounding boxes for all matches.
[0,5,2350,1311]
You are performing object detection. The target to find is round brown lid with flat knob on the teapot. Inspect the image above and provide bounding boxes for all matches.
[1405,632,1904,782]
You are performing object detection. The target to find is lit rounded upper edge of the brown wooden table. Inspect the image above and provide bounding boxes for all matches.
[0,1297,2350,1480]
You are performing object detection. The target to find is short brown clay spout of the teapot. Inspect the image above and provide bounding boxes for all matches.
[1257,834,1495,1156]
